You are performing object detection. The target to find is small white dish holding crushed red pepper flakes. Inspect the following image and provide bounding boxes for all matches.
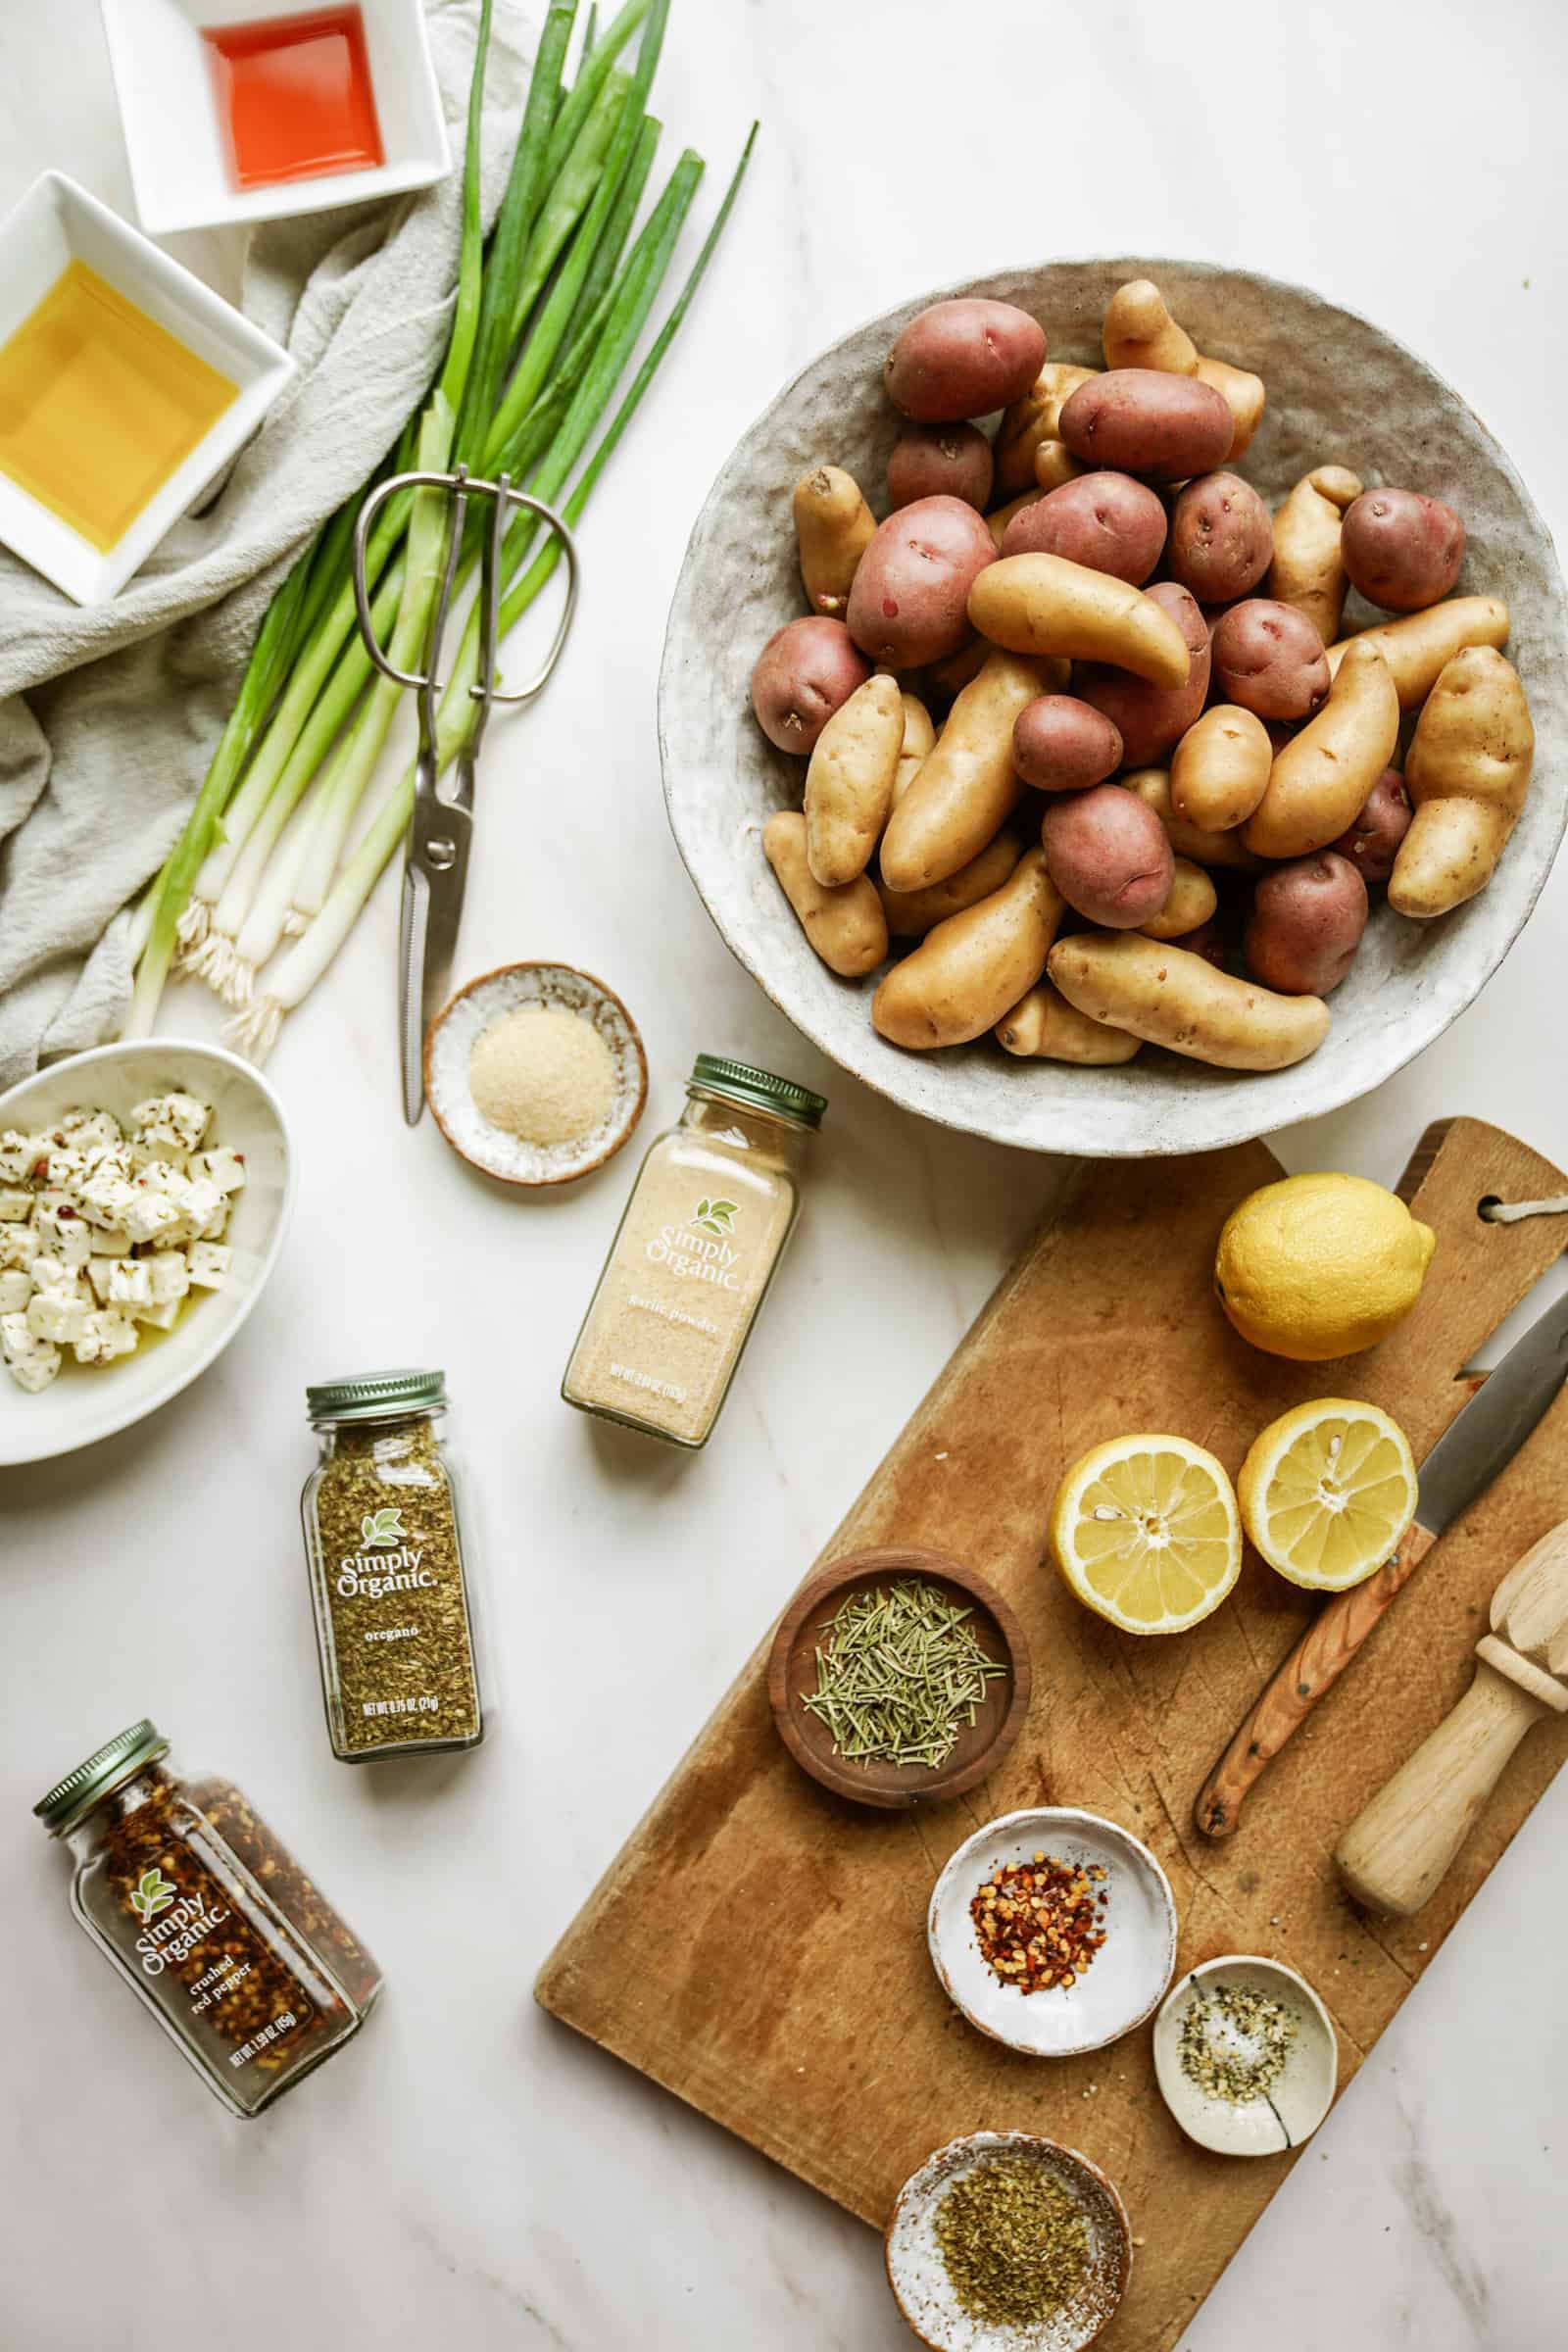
[926,1806,1175,2058]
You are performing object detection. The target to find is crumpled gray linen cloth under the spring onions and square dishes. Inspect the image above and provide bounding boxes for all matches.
[0,0,526,1087]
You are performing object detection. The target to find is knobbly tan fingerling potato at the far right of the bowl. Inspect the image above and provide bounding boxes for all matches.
[1400,645,1535,922]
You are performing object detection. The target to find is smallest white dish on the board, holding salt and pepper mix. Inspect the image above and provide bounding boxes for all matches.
[1154,1952,1340,2157]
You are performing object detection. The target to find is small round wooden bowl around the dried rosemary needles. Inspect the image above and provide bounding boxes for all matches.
[768,1547,1032,1809]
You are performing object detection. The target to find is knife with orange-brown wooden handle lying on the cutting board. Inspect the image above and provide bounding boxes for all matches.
[1192,1296,1568,1839]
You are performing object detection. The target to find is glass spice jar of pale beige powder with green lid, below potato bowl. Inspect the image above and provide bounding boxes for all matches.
[562,1054,827,1446]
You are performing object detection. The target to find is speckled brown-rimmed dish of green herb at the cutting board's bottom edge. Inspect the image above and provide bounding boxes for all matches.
[884,2131,1133,2352]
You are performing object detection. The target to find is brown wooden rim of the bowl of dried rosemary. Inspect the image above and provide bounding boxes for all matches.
[766,1543,1034,1813]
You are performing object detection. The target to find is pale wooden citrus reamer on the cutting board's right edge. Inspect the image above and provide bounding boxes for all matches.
[1333,1519,1568,1917]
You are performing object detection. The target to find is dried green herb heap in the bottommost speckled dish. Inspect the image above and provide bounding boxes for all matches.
[933,2157,1091,2328]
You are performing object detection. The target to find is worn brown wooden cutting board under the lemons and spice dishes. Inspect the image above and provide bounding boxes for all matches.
[536,1119,1568,2352]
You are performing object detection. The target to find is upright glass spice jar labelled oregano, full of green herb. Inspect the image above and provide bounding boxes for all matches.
[301,1371,484,1764]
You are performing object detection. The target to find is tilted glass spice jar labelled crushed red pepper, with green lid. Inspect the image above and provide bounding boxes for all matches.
[33,1722,381,2117]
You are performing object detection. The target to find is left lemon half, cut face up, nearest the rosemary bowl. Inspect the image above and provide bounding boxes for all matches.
[1051,1437,1242,1633]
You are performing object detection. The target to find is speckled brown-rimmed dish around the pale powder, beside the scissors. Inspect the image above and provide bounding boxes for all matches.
[425,964,649,1186]
